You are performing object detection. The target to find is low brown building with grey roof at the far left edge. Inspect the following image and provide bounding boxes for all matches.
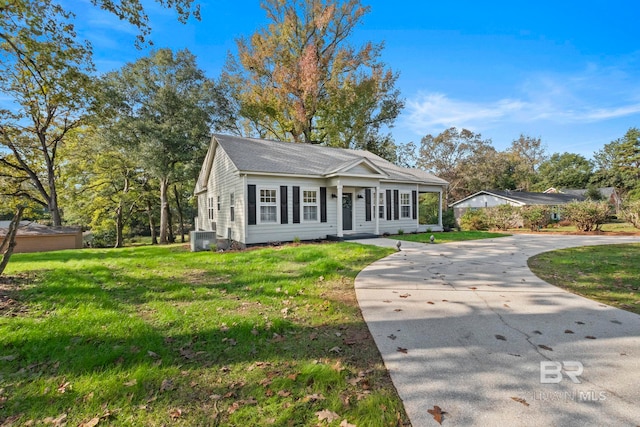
[0,221,82,253]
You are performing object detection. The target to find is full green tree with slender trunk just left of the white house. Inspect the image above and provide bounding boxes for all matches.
[103,49,228,243]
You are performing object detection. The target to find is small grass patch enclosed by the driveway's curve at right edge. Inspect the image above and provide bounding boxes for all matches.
[528,244,640,314]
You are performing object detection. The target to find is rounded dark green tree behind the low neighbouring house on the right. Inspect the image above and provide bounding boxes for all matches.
[536,153,593,190]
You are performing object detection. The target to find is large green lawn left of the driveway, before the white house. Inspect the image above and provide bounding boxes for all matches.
[0,243,407,426]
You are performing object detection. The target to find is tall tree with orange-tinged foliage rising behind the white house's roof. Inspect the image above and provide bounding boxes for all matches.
[223,0,403,154]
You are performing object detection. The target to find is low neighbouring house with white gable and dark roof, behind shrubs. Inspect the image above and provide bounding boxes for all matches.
[449,190,584,224]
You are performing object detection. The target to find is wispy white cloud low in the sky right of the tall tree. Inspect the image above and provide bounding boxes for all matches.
[400,67,640,135]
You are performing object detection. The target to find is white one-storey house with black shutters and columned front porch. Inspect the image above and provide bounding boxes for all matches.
[195,135,447,245]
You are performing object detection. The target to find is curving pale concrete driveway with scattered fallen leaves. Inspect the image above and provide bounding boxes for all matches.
[355,235,640,427]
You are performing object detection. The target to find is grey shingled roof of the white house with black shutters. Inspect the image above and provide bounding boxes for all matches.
[202,134,447,186]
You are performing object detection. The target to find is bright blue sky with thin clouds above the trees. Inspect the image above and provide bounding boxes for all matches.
[73,0,640,157]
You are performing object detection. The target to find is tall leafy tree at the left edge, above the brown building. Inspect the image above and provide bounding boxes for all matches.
[0,1,93,225]
